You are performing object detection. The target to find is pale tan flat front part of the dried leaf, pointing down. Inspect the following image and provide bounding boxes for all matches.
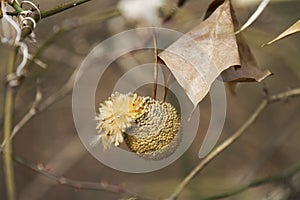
[159,0,241,106]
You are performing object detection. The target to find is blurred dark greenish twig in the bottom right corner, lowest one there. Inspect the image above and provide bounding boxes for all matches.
[203,163,300,200]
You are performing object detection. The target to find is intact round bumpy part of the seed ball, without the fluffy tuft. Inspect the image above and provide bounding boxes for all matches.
[125,97,181,159]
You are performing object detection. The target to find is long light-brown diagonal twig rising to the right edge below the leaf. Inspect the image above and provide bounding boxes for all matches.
[167,88,300,200]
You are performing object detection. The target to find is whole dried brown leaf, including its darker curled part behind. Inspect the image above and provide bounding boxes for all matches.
[159,0,271,106]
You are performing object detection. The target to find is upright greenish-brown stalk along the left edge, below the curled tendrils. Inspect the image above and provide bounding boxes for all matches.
[3,48,18,200]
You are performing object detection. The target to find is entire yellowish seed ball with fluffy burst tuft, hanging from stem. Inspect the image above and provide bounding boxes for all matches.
[96,93,181,159]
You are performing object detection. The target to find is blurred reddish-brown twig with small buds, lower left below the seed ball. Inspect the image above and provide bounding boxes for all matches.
[14,157,150,200]
